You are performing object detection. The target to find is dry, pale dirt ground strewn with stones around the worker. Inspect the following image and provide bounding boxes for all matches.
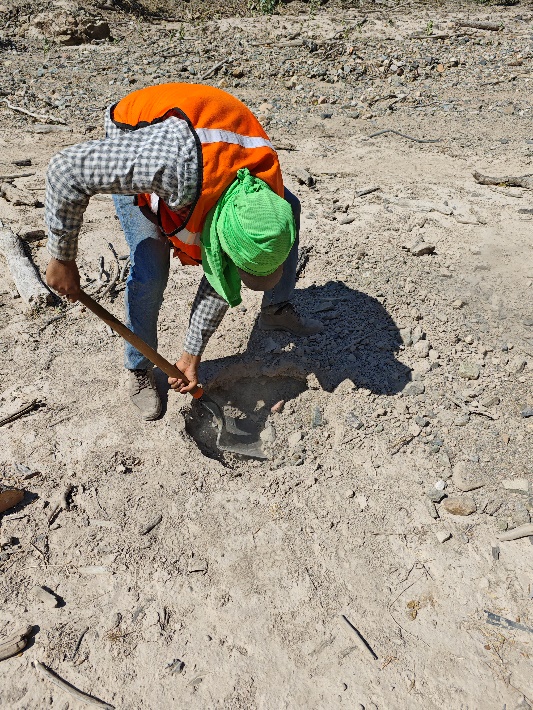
[0,5,533,710]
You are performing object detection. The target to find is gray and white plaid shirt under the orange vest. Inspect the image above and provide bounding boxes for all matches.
[45,109,228,355]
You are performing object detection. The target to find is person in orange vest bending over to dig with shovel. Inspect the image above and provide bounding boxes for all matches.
[45,83,323,420]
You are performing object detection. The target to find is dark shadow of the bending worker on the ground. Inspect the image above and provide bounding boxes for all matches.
[200,281,411,395]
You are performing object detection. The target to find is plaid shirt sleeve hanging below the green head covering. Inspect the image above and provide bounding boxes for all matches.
[184,276,229,355]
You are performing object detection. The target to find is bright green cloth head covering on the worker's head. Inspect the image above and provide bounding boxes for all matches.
[200,168,296,306]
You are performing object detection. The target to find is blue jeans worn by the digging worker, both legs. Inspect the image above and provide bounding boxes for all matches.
[113,188,301,370]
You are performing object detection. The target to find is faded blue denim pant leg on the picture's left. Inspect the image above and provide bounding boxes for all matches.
[113,195,170,370]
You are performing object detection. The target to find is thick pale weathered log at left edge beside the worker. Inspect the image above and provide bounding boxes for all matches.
[0,221,54,308]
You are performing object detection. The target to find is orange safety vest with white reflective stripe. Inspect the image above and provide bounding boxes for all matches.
[111,84,283,264]
